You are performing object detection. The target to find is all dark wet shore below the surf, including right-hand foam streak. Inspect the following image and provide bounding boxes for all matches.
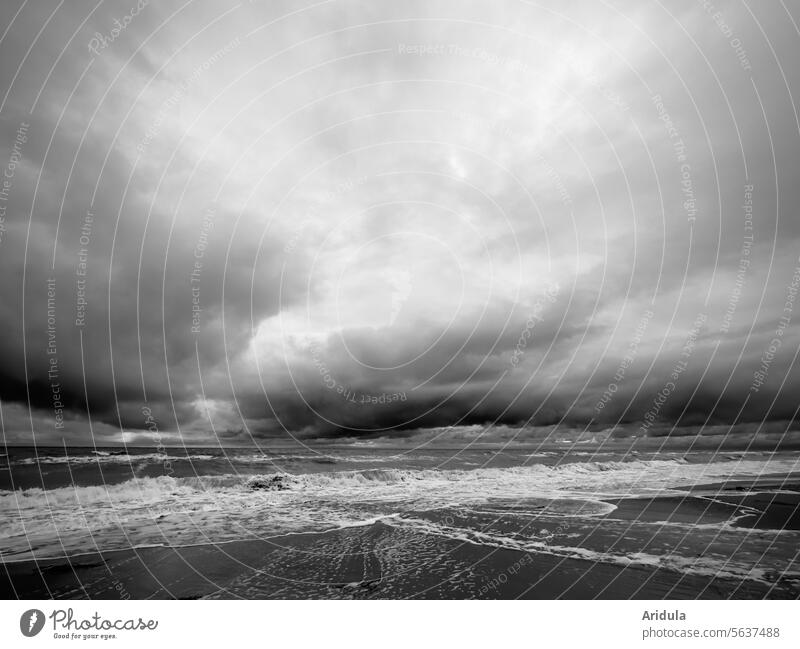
[0,466,800,599]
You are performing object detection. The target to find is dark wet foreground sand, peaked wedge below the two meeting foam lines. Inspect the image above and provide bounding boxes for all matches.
[0,522,797,599]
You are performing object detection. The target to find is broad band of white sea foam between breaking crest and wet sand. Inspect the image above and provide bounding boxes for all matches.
[0,459,797,559]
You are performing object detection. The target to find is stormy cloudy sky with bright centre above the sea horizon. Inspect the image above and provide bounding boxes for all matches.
[0,0,800,445]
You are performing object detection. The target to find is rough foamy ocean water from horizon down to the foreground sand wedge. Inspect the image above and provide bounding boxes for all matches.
[0,445,800,588]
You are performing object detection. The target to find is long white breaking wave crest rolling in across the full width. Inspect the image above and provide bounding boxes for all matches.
[6,456,800,504]
